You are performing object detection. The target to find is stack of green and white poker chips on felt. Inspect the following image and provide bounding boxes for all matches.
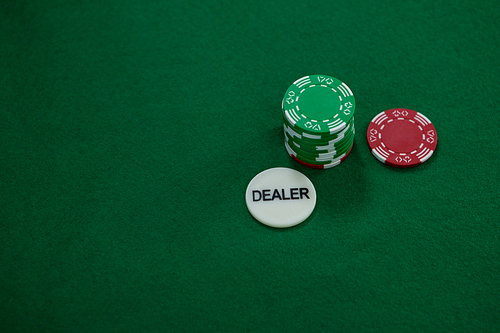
[281,75,356,169]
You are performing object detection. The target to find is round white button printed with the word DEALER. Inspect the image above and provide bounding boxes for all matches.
[245,168,316,228]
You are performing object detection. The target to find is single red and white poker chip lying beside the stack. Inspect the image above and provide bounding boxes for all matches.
[366,109,437,168]
